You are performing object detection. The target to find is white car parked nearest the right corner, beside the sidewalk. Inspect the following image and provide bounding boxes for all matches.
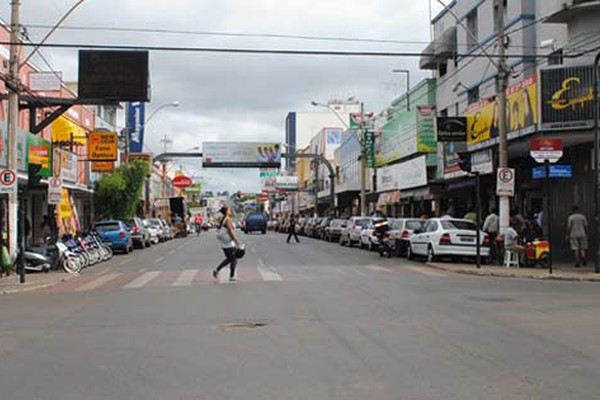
[406,218,490,262]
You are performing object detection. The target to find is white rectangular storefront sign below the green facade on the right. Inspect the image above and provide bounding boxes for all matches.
[377,155,427,192]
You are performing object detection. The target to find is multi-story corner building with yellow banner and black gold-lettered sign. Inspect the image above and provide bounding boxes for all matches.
[420,0,600,256]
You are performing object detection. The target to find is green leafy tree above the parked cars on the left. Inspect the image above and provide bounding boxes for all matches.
[94,160,150,219]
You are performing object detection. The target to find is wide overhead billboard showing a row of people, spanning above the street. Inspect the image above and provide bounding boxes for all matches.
[202,142,281,168]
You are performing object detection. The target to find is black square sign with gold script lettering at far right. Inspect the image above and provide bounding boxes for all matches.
[540,65,594,130]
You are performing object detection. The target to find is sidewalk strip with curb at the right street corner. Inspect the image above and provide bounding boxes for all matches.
[427,262,600,282]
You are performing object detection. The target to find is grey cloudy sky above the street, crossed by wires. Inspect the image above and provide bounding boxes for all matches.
[0,0,446,191]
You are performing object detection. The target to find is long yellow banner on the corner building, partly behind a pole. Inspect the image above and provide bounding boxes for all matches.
[467,74,538,150]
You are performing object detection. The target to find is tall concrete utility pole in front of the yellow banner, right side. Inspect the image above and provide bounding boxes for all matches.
[496,0,510,234]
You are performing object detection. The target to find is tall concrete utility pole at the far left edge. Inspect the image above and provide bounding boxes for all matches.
[7,0,21,260]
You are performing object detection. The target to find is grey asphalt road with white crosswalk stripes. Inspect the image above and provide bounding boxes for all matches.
[0,233,600,400]
